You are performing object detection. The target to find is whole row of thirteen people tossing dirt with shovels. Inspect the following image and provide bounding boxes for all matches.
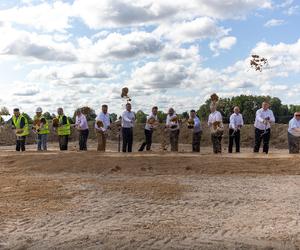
[4,102,300,154]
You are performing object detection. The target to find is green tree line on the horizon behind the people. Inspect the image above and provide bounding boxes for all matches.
[0,95,300,124]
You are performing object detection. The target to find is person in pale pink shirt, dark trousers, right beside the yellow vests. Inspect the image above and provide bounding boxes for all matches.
[74,109,89,150]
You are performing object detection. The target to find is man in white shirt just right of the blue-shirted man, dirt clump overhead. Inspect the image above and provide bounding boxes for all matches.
[208,104,224,154]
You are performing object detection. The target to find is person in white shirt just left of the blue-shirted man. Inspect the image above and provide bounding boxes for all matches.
[166,108,180,152]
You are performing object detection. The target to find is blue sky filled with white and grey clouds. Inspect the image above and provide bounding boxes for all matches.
[0,0,300,114]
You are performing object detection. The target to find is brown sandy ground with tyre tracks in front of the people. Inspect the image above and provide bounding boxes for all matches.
[0,143,300,249]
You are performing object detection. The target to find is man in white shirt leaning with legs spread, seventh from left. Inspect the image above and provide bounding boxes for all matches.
[139,106,158,151]
